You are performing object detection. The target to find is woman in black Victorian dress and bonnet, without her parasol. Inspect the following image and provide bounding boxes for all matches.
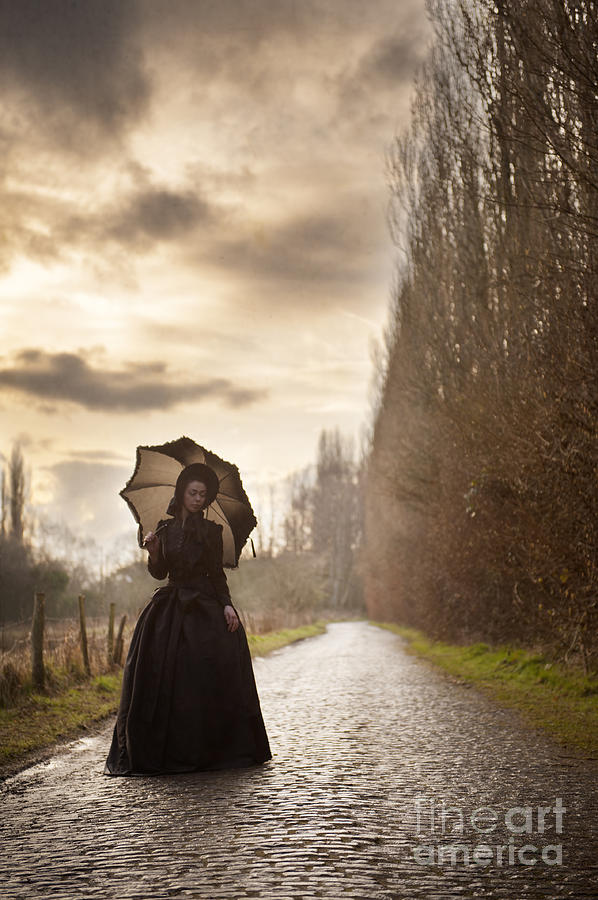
[104,463,271,775]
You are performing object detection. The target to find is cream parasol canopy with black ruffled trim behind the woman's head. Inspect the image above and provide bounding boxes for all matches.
[120,437,257,568]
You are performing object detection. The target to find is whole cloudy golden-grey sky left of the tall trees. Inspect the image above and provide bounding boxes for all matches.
[0,0,429,560]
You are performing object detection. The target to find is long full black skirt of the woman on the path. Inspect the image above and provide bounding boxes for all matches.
[104,581,271,775]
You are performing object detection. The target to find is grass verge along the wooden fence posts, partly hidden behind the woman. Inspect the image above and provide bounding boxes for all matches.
[0,622,326,775]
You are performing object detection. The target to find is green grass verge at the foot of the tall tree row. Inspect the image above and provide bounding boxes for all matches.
[370,622,598,757]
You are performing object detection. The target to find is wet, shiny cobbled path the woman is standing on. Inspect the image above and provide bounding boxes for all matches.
[0,622,598,900]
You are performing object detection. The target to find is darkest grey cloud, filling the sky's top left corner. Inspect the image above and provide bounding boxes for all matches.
[0,0,150,142]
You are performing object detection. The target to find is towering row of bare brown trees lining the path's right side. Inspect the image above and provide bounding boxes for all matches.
[366,0,598,666]
